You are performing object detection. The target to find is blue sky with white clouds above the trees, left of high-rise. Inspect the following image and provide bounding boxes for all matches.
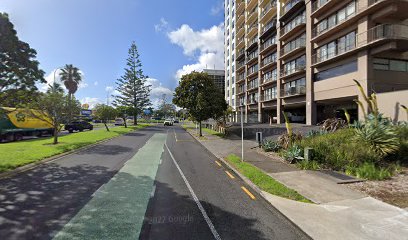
[0,0,224,107]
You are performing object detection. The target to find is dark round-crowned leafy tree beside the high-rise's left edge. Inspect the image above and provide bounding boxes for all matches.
[173,72,228,136]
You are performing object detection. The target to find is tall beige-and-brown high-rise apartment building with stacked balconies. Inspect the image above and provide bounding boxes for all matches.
[226,0,408,124]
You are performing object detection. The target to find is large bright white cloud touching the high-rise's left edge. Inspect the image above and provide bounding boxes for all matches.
[167,23,224,80]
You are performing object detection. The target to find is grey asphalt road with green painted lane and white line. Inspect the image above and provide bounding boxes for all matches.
[0,126,308,239]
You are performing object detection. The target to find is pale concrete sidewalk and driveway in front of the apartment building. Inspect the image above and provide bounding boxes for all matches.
[185,126,408,240]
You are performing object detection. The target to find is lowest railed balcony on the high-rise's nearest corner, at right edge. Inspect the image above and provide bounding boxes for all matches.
[312,24,408,65]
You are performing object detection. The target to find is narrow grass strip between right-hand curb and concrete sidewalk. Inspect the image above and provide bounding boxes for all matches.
[227,154,313,203]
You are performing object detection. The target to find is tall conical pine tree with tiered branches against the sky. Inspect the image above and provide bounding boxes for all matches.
[113,42,151,125]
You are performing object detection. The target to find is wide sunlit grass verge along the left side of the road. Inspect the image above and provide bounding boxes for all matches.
[0,124,148,172]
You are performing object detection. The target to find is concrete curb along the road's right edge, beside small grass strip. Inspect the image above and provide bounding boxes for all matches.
[183,128,313,239]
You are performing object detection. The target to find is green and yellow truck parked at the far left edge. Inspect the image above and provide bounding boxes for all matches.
[0,107,54,142]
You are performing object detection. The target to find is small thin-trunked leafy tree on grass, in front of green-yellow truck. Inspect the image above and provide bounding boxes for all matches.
[28,88,81,144]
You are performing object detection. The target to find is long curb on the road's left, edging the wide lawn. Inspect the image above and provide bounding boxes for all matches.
[0,129,148,180]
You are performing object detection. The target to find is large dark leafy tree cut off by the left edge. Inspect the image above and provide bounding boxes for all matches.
[0,13,45,107]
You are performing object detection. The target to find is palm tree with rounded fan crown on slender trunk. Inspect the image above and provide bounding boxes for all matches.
[59,64,82,122]
